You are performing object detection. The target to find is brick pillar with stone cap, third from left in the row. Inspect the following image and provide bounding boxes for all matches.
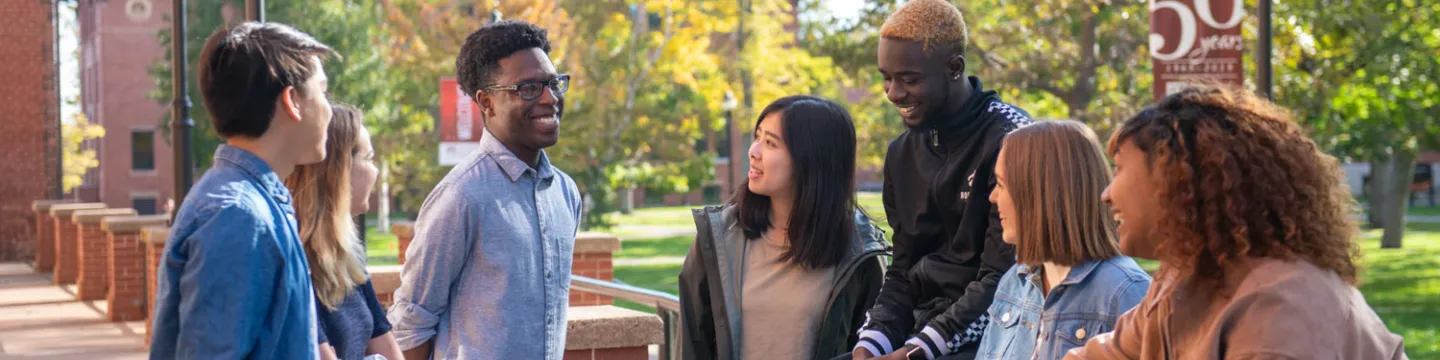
[71,209,135,300]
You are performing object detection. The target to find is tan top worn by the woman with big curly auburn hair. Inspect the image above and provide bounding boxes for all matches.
[1066,259,1405,360]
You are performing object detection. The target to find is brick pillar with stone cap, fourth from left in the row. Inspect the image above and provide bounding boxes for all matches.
[101,215,168,321]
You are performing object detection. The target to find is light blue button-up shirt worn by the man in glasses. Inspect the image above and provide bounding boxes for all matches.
[389,131,580,360]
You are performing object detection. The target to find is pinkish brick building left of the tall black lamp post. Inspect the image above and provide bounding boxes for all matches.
[76,0,173,215]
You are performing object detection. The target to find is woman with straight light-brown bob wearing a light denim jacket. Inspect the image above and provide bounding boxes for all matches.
[976,121,1151,359]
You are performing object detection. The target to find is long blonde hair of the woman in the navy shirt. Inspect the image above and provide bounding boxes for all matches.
[285,105,366,310]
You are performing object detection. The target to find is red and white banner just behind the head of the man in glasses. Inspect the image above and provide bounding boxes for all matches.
[439,78,485,166]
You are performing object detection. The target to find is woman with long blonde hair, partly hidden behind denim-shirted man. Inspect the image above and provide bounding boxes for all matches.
[285,104,403,360]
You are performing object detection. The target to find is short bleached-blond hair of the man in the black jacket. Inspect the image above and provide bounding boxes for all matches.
[880,0,969,55]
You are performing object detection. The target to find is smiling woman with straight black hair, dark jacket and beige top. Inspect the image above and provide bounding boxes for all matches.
[680,95,887,359]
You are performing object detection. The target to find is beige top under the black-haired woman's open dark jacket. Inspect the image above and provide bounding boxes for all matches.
[740,231,835,359]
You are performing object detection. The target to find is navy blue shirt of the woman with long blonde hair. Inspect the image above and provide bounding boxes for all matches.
[315,279,390,360]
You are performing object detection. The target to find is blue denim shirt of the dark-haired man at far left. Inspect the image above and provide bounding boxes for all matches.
[150,145,320,359]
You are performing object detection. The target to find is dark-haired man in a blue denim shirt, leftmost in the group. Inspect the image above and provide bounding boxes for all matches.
[150,23,334,359]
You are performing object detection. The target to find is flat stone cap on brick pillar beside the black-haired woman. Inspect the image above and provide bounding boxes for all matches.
[564,305,665,350]
